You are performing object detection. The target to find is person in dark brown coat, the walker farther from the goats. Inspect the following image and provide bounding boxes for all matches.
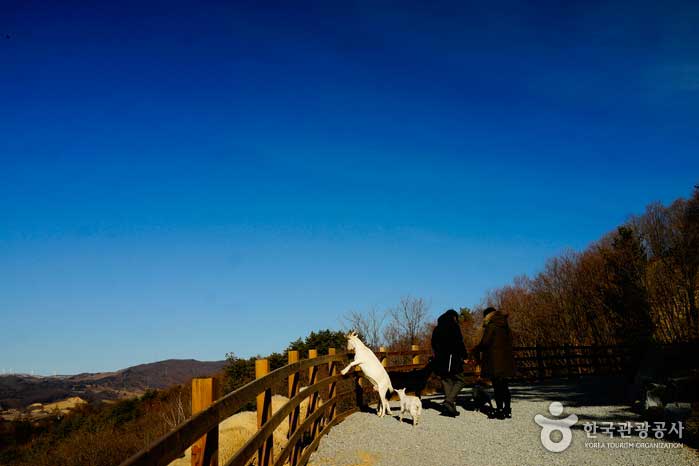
[474,307,515,418]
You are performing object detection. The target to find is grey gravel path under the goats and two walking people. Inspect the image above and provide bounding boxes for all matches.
[310,379,699,466]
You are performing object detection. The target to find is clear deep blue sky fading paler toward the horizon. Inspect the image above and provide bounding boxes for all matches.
[0,0,699,374]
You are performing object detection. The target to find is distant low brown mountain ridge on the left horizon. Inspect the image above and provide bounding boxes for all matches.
[0,359,226,410]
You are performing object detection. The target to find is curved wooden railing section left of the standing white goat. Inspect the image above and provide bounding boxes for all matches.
[121,349,360,466]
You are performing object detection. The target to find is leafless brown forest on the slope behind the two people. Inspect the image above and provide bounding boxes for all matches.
[344,187,699,349]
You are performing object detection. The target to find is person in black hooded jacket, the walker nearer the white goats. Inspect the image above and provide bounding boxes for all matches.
[432,309,468,417]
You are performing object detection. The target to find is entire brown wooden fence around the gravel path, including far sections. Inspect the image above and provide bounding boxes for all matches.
[121,345,628,466]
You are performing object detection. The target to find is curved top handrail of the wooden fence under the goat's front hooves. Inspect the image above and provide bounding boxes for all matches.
[120,353,347,466]
